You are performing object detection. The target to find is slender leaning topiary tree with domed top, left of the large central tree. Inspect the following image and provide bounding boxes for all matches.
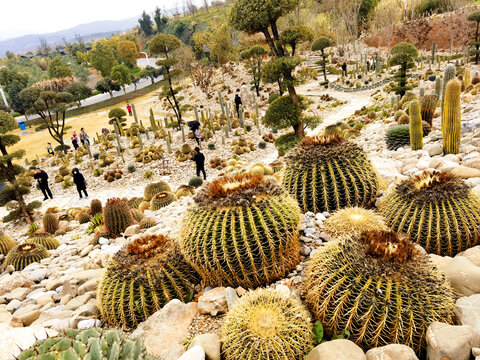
[149,34,184,127]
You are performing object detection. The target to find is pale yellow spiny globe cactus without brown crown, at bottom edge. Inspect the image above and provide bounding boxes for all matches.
[222,289,314,360]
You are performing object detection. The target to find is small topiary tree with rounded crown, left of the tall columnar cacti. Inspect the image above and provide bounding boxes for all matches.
[390,42,418,96]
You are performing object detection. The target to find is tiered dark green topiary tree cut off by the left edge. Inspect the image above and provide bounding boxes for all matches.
[0,110,34,224]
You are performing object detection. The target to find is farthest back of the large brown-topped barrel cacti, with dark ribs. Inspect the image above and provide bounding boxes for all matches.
[283,135,379,213]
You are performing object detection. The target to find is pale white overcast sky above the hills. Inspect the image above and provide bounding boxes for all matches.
[0,0,195,40]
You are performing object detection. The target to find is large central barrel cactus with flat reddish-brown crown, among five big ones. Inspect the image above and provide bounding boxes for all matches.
[181,174,300,288]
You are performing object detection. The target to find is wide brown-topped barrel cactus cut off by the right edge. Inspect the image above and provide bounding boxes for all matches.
[379,172,480,256]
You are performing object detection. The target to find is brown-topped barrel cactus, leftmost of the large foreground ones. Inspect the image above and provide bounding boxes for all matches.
[97,235,199,329]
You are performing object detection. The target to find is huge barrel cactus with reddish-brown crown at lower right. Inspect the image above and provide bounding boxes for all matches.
[306,230,455,355]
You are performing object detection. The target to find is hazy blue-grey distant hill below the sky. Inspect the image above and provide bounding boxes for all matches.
[0,16,139,56]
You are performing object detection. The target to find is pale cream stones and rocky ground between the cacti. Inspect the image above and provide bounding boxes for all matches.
[0,54,480,360]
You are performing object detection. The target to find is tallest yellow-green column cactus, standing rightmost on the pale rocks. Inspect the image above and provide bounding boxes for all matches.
[442,79,462,154]
